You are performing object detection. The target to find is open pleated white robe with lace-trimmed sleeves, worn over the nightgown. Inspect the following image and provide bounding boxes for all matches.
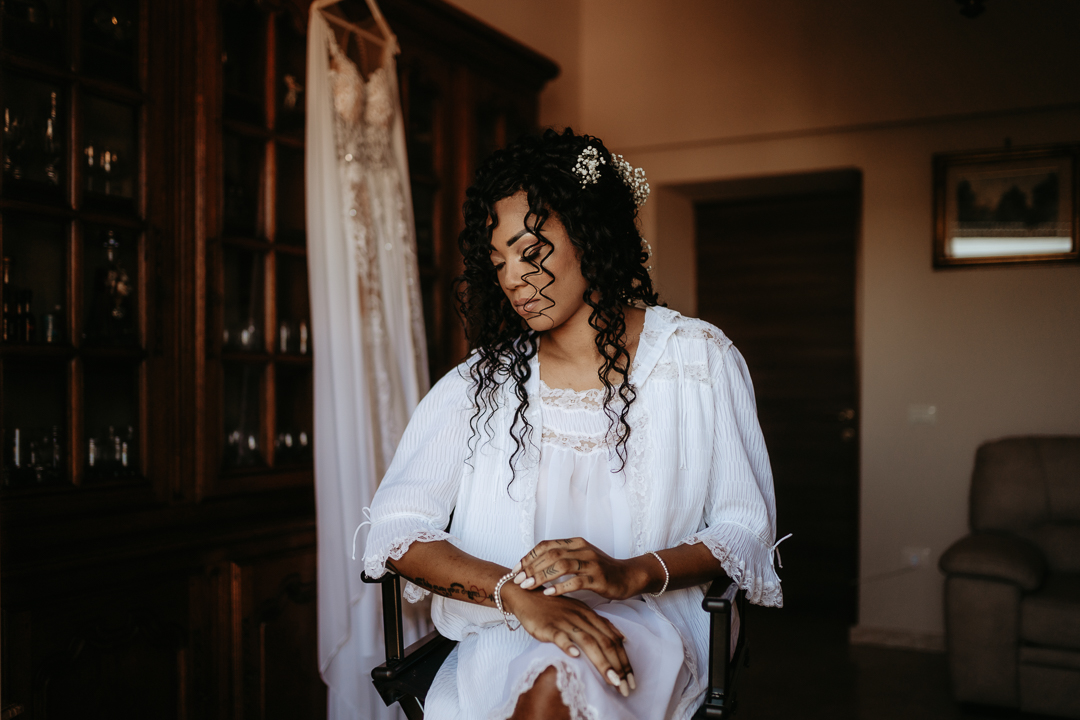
[364,308,782,720]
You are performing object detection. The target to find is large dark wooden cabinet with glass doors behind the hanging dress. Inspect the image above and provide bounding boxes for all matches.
[0,0,557,719]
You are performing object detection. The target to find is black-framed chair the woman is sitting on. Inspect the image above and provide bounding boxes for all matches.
[363,571,750,720]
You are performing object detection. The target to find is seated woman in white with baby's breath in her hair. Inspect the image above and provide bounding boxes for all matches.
[364,130,782,720]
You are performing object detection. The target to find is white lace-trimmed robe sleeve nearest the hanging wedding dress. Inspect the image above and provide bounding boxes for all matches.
[364,367,473,602]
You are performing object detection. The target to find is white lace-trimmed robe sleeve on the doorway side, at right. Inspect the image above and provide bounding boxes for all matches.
[683,336,784,608]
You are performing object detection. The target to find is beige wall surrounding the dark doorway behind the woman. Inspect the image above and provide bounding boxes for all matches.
[438,0,1080,639]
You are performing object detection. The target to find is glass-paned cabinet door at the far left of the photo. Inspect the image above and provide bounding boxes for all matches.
[0,0,151,493]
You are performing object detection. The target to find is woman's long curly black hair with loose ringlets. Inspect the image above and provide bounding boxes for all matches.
[457,127,659,481]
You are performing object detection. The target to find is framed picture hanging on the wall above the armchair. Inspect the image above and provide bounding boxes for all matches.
[933,146,1080,268]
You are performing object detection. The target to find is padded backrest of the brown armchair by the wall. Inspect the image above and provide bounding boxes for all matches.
[971,435,1080,572]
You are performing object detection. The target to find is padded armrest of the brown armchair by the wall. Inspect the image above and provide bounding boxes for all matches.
[937,532,1047,593]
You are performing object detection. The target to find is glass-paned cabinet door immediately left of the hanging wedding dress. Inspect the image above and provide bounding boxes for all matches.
[207,0,314,492]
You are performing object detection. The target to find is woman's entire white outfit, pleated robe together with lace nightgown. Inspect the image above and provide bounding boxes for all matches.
[363,308,783,720]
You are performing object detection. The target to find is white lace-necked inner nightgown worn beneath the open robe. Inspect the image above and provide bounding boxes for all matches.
[428,380,690,720]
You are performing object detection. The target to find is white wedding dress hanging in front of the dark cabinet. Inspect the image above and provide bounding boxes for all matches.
[305,8,428,720]
